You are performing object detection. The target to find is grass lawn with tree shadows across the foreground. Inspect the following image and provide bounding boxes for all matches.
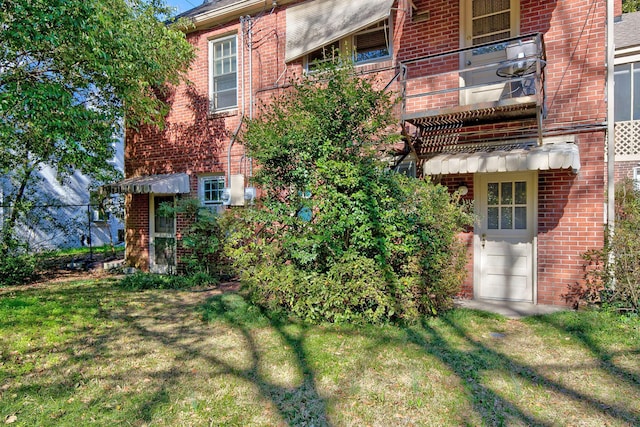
[0,277,640,426]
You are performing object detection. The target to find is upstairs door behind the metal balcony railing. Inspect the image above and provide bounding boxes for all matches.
[460,0,520,104]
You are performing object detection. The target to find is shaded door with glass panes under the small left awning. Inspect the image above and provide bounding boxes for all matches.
[149,194,176,274]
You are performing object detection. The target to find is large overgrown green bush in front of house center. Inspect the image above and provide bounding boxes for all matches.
[224,63,470,323]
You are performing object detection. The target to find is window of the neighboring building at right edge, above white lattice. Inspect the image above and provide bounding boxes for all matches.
[613,62,640,122]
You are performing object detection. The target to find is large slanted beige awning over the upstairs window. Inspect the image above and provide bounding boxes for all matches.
[285,0,394,62]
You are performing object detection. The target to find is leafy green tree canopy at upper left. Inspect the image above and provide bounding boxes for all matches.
[0,0,194,254]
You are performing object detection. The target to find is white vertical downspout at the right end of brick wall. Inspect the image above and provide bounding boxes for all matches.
[606,0,619,247]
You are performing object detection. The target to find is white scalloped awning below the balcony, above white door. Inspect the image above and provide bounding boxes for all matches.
[423,142,580,175]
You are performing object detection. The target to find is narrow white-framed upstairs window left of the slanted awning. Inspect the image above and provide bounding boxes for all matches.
[209,36,238,111]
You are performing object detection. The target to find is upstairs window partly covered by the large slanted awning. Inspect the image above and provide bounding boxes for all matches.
[306,19,391,71]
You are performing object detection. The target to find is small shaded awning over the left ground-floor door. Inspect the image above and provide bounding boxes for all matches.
[102,173,191,194]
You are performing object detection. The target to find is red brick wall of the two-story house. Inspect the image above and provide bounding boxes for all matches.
[125,0,606,303]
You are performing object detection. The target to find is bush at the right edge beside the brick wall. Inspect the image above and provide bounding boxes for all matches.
[566,180,640,314]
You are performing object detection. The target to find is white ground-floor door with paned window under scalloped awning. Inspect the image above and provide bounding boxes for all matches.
[474,172,537,302]
